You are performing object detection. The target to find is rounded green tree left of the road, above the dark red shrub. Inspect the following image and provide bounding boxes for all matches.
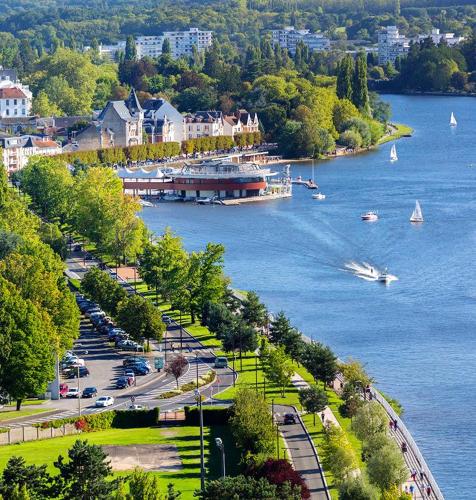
[230,387,275,456]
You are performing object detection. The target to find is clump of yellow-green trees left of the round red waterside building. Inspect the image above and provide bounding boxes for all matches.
[18,157,148,263]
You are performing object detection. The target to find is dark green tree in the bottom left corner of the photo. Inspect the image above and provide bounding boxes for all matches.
[0,456,53,500]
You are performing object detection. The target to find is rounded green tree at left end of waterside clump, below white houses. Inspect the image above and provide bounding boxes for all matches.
[20,156,74,222]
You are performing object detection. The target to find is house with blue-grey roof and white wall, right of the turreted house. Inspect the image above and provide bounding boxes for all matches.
[142,99,185,142]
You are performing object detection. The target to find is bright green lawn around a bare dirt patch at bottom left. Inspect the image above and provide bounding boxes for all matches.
[0,426,239,499]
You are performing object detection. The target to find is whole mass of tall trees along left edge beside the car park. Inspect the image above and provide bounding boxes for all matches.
[0,158,79,410]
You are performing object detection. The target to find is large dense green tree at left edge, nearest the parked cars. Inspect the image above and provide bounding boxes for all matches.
[0,278,55,410]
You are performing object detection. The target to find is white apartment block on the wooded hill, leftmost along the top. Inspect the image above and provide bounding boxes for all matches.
[136,28,213,59]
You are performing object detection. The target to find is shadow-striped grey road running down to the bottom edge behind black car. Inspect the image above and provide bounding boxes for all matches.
[274,405,330,500]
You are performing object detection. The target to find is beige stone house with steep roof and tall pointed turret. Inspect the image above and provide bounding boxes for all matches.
[72,89,144,151]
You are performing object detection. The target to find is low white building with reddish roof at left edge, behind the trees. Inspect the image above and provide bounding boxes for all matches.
[0,135,62,173]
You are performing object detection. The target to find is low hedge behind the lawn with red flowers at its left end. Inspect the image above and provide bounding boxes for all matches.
[36,408,160,432]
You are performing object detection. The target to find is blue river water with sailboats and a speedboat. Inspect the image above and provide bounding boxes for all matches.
[143,96,476,499]
